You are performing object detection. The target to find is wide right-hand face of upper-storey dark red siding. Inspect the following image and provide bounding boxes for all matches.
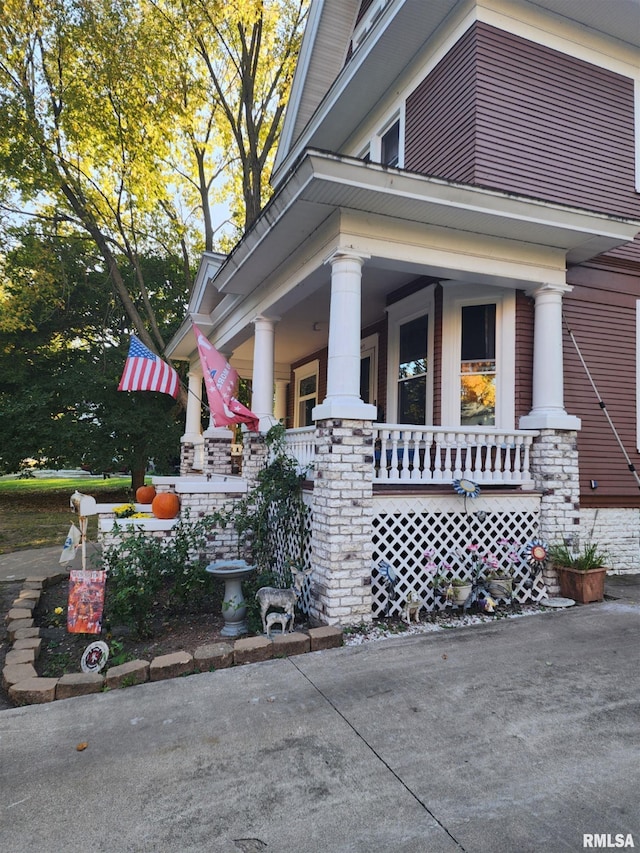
[474,23,640,217]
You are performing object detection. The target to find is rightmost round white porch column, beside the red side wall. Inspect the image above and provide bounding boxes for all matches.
[520,284,580,430]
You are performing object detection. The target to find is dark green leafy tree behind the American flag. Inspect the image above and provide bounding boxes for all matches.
[0,225,183,486]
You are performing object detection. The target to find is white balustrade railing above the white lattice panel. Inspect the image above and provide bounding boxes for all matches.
[373,424,538,488]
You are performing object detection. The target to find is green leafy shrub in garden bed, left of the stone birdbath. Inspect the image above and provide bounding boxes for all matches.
[102,513,219,637]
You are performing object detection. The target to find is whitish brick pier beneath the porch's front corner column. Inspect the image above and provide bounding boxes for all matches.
[310,420,373,625]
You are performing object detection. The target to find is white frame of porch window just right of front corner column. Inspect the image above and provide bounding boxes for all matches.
[385,286,435,424]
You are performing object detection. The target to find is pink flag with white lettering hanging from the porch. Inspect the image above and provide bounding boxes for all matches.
[193,323,259,432]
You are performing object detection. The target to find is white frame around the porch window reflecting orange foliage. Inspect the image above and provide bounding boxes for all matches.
[441,282,516,429]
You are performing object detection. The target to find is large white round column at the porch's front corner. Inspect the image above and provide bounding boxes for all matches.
[312,249,376,421]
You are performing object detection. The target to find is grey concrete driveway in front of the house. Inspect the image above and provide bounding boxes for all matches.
[0,598,640,853]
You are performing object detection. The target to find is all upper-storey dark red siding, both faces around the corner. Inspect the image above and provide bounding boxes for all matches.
[405,23,640,217]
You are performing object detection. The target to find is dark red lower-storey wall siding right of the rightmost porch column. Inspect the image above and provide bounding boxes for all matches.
[564,266,640,506]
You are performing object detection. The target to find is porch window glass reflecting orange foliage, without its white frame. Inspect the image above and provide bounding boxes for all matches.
[460,303,496,426]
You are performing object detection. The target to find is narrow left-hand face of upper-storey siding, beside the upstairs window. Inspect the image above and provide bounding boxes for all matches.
[404,30,476,183]
